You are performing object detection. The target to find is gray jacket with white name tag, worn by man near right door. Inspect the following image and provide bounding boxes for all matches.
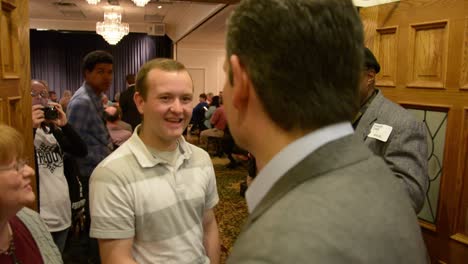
[355,91,429,213]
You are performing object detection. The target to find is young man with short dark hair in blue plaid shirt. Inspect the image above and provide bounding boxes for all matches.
[67,50,113,263]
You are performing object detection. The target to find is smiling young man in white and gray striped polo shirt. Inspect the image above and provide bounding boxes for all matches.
[90,59,219,263]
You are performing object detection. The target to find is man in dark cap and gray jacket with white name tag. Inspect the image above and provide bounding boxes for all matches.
[353,48,429,213]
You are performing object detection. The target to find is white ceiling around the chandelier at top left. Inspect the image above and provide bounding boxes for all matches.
[29,0,232,43]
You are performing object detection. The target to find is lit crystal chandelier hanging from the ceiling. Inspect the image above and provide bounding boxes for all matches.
[96,6,128,45]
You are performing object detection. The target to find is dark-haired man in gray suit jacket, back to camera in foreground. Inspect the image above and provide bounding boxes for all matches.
[223,0,427,264]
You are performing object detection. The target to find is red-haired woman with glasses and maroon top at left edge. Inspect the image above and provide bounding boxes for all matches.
[0,124,62,264]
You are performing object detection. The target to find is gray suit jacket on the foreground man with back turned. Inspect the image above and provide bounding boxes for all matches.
[228,136,427,264]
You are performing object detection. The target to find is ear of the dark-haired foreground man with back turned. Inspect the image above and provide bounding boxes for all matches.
[229,55,250,110]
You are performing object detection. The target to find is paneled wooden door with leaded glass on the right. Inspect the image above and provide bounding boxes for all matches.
[359,0,468,264]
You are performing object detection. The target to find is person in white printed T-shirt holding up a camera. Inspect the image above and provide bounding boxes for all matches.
[31,80,87,252]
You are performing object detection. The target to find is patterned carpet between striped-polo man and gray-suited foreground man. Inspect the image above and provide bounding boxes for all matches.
[213,161,247,263]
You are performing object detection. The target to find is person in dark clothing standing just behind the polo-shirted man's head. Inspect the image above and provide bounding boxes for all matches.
[119,74,141,130]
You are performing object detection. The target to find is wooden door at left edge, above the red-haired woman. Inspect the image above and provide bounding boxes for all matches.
[0,0,37,208]
